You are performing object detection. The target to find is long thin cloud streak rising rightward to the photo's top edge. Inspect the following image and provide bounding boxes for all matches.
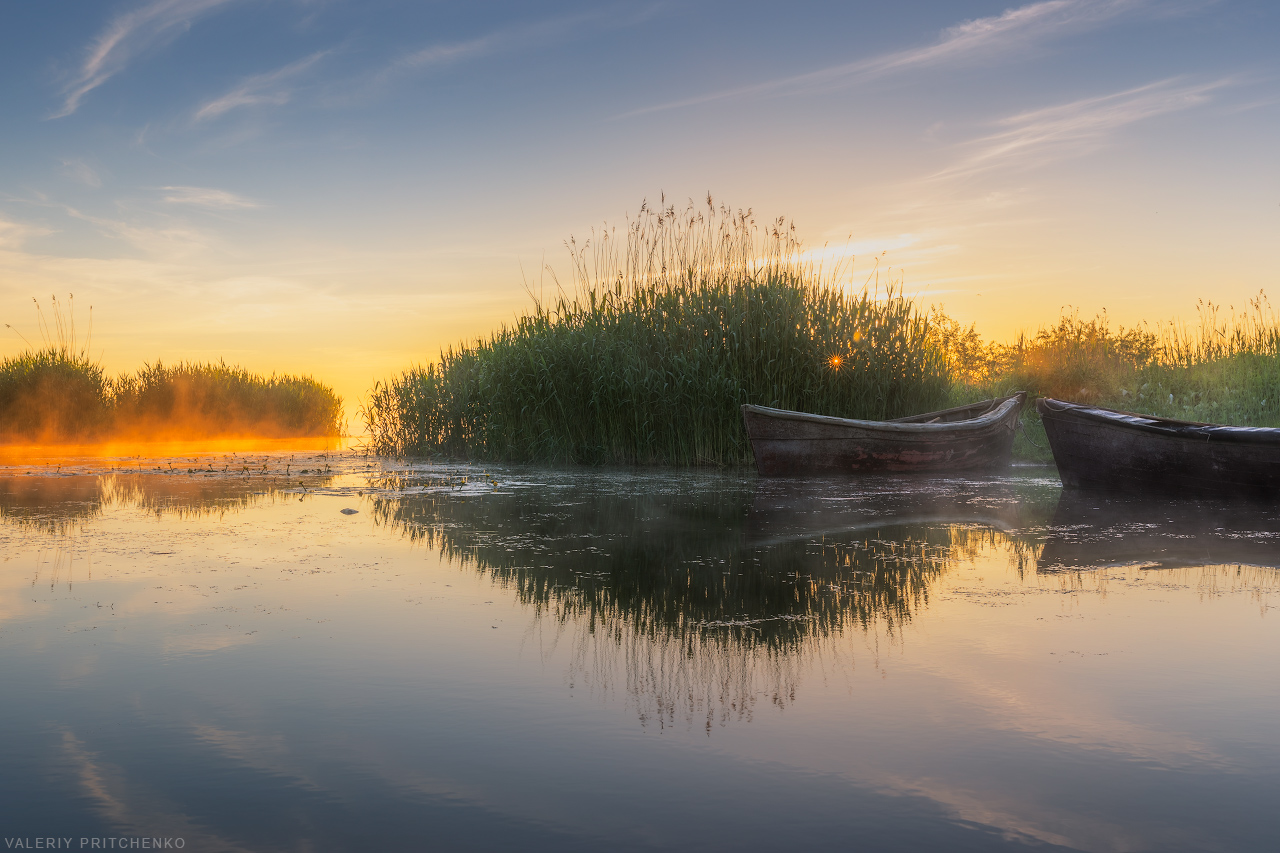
[616,0,1151,119]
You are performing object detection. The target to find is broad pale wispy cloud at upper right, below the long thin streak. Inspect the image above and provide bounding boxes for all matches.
[934,78,1234,178]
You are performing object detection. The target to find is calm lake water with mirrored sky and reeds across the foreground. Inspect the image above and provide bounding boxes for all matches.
[0,453,1280,850]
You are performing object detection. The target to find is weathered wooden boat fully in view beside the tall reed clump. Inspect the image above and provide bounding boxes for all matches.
[742,391,1027,476]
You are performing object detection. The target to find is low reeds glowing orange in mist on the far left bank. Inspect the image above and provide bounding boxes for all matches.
[0,298,343,446]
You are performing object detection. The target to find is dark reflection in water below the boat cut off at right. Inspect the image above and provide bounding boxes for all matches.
[1038,492,1280,571]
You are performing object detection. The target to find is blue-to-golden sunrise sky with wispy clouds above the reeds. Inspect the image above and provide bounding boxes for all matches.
[0,0,1280,412]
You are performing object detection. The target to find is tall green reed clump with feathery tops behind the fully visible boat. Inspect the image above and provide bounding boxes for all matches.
[362,197,950,465]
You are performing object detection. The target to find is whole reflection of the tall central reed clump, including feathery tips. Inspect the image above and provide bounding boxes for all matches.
[372,481,1029,726]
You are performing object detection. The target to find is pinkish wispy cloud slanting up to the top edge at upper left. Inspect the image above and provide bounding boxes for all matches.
[50,0,240,118]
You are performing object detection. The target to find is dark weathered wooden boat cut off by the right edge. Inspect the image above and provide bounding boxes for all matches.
[1036,397,1280,498]
